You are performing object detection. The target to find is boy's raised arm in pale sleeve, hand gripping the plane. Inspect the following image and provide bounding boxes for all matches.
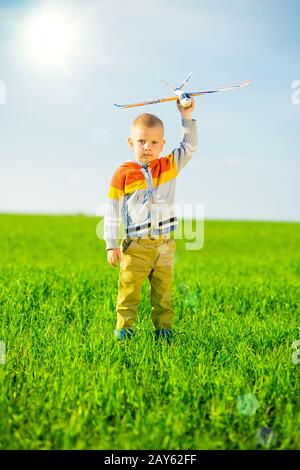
[172,97,198,172]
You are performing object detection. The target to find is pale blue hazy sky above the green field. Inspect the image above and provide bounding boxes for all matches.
[0,0,300,221]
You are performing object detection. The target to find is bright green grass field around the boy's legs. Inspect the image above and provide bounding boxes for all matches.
[0,214,300,450]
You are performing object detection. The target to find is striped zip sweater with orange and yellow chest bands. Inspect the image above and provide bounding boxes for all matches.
[104,119,197,250]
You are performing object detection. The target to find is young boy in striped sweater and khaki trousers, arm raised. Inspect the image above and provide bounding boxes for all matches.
[104,99,197,340]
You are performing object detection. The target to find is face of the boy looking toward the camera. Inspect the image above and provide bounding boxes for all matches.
[128,124,166,163]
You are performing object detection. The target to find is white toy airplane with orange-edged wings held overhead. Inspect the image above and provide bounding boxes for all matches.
[115,72,251,108]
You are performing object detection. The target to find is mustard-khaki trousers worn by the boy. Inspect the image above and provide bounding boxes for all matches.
[116,236,176,330]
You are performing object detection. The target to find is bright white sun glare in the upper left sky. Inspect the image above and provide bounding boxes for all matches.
[26,11,78,67]
